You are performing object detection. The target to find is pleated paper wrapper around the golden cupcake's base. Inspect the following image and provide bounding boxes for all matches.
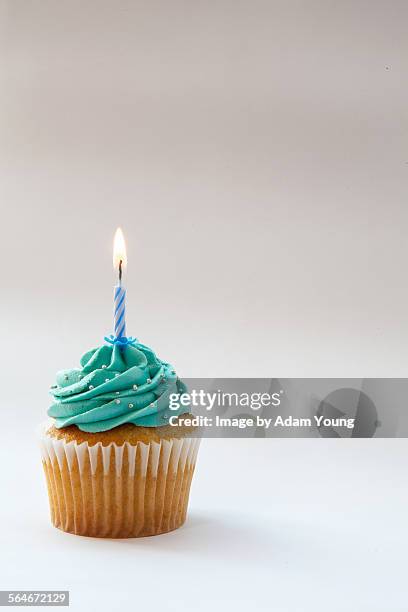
[40,423,200,538]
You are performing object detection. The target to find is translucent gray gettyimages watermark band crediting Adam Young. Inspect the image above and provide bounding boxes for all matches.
[165,379,402,438]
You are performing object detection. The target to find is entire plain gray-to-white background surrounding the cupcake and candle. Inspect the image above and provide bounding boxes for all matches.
[0,0,408,612]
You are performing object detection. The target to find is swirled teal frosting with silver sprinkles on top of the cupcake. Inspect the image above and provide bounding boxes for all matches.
[48,343,188,432]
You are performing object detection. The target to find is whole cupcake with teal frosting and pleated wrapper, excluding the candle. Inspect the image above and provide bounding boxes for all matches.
[40,341,200,538]
